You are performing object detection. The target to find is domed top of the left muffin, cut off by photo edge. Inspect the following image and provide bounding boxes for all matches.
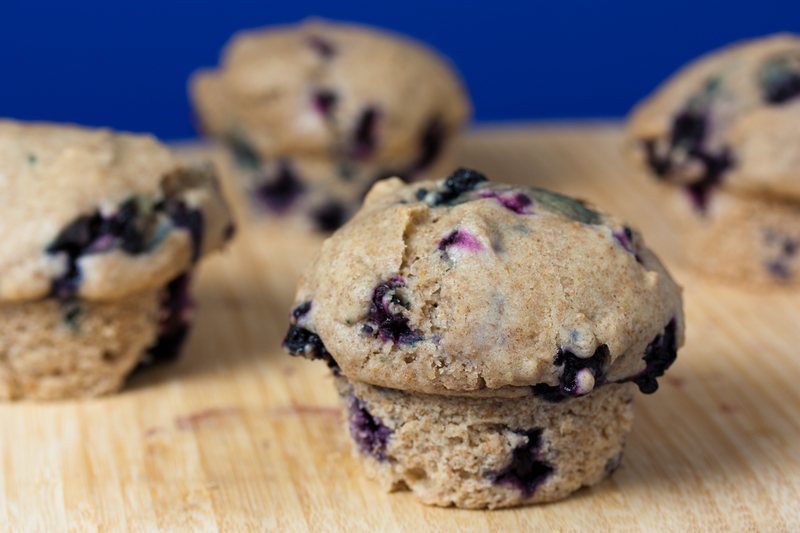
[0,121,233,301]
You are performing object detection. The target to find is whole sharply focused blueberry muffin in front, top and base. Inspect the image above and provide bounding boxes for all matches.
[284,169,684,508]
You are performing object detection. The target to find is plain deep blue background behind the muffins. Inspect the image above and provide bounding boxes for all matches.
[0,0,800,139]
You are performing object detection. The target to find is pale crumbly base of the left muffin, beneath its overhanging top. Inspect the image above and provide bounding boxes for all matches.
[0,282,173,400]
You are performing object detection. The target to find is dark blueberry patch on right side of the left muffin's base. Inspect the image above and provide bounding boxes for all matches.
[140,274,194,366]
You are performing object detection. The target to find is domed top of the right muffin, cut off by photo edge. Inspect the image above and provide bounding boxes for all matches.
[629,34,800,210]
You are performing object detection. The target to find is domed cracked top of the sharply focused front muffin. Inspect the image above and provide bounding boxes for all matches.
[284,169,683,400]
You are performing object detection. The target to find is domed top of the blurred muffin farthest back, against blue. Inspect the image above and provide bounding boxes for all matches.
[190,20,469,160]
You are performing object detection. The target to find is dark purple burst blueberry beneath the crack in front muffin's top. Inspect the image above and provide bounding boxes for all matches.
[361,276,422,344]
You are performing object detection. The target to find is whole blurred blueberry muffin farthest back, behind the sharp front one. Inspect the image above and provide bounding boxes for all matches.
[190,20,469,231]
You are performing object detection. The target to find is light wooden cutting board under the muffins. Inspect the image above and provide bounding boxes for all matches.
[0,124,800,531]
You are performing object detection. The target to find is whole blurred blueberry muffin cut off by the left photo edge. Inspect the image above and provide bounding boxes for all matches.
[0,121,233,399]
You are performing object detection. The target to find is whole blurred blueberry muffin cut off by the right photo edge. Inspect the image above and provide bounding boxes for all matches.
[629,34,800,284]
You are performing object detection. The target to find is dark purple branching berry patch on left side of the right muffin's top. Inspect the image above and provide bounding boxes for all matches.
[643,78,734,213]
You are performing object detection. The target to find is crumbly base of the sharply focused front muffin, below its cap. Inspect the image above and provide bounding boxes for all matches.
[336,377,635,509]
